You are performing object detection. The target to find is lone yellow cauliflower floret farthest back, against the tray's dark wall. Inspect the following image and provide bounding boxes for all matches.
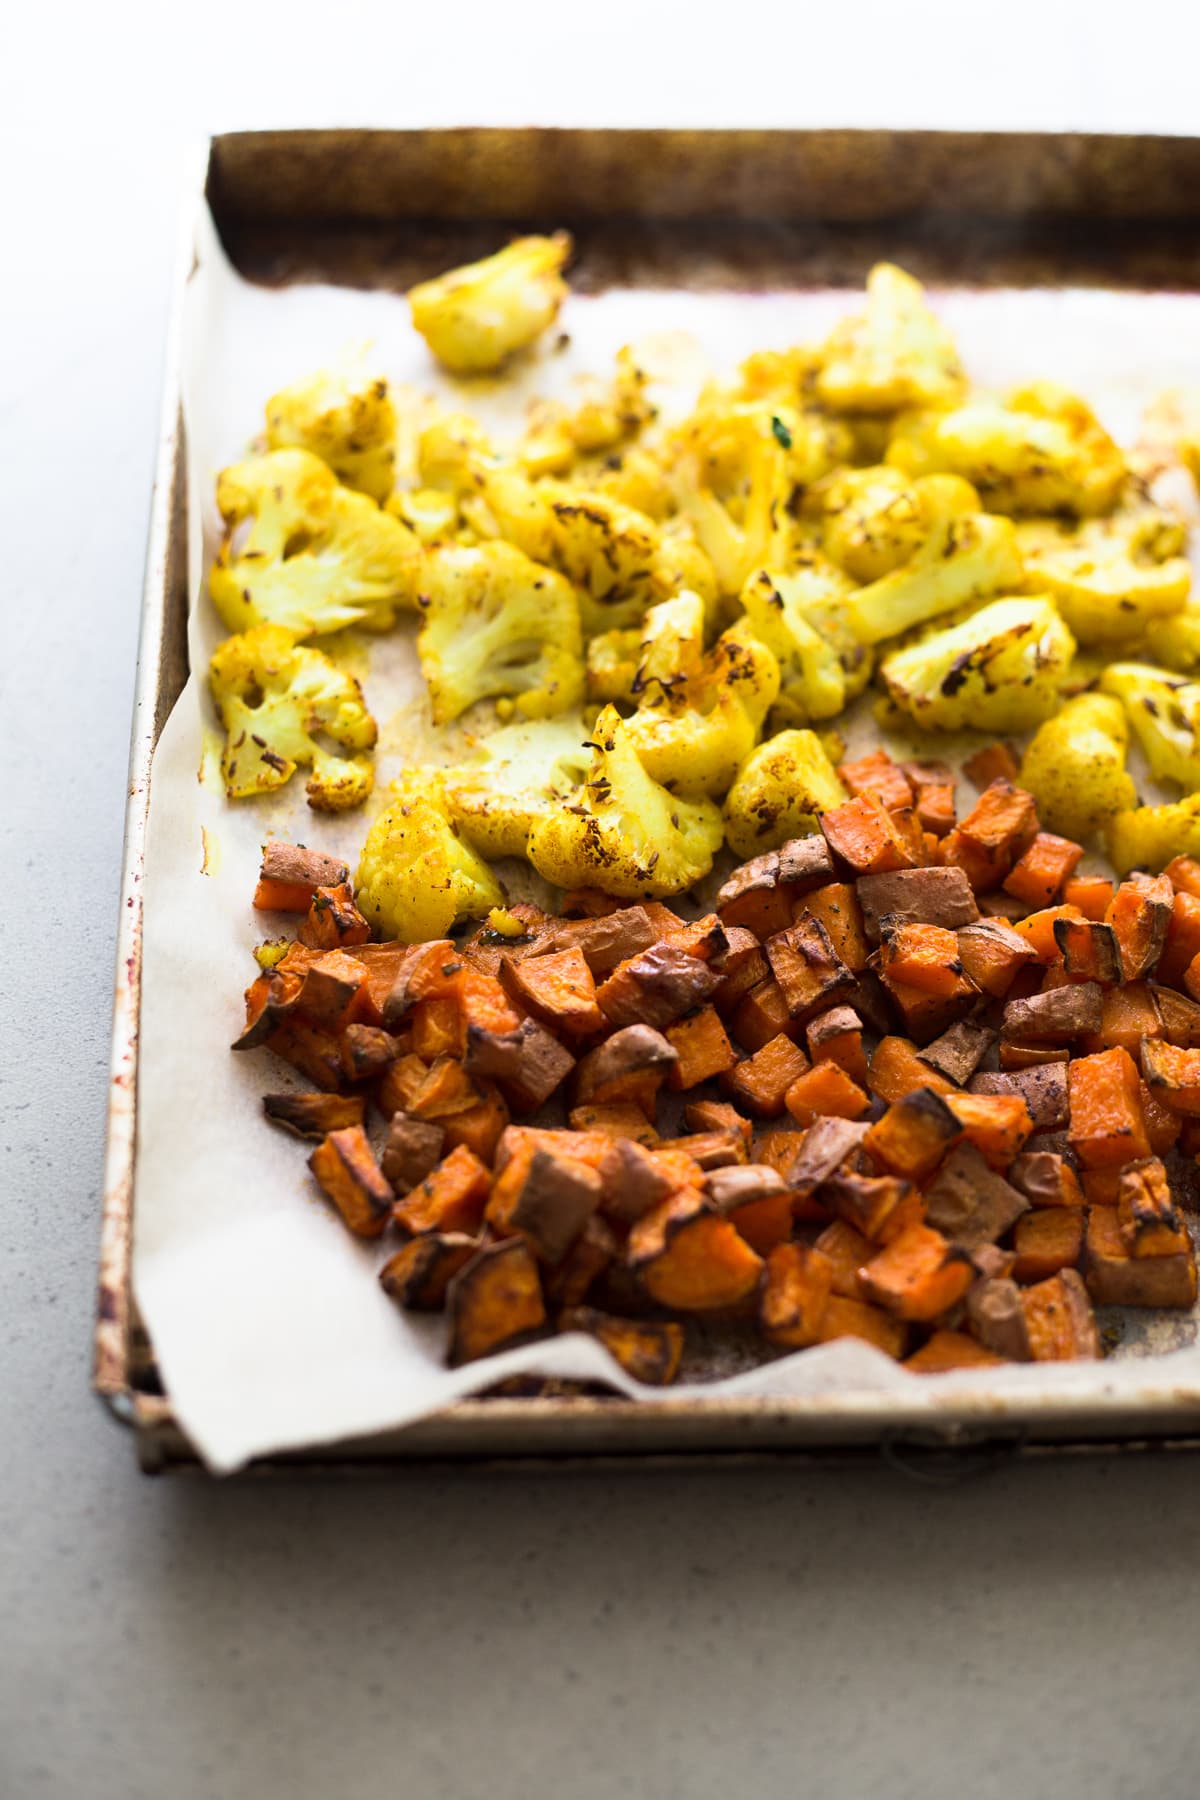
[408,230,570,374]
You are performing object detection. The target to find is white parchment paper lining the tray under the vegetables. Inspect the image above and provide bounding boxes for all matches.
[133,200,1200,1471]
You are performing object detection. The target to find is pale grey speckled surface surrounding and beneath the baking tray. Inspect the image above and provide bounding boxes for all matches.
[0,0,1200,1800]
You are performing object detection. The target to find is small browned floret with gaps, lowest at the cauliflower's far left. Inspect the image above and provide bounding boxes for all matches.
[209,625,376,812]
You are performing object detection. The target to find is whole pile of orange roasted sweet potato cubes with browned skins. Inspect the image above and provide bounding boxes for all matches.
[234,745,1200,1384]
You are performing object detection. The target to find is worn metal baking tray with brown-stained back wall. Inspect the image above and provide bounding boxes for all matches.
[94,128,1200,1471]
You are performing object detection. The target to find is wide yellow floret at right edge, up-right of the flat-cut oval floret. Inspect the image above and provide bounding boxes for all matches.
[1016,506,1191,644]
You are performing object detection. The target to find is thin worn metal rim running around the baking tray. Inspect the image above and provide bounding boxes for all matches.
[92,126,1200,1469]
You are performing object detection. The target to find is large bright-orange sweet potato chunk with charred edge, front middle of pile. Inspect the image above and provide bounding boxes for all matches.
[628,1188,763,1312]
